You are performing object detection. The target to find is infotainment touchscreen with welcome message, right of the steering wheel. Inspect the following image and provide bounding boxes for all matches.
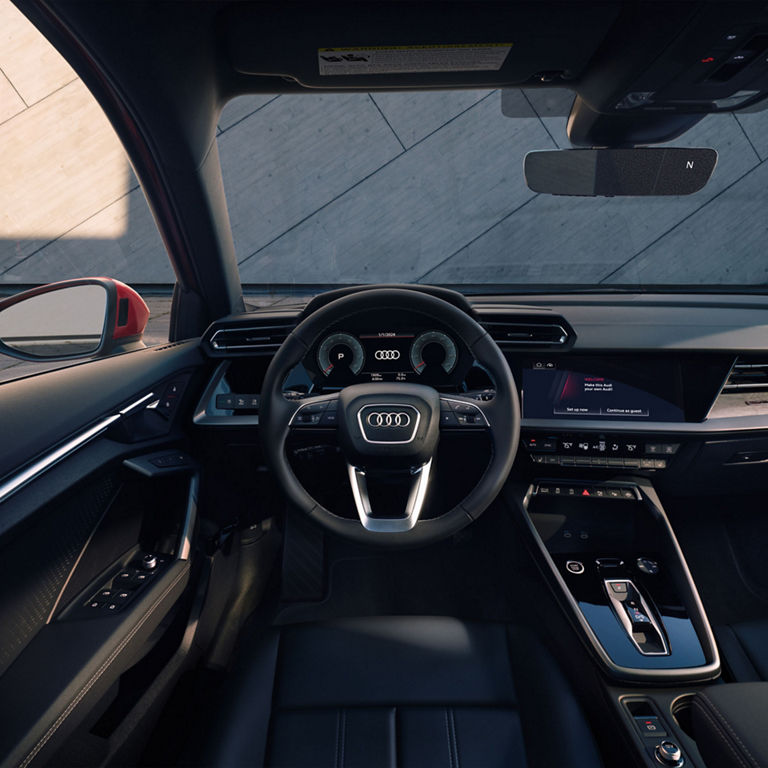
[523,359,685,421]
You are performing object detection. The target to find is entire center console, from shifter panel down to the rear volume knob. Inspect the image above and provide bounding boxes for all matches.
[509,476,720,768]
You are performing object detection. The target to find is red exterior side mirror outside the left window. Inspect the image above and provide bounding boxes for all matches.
[0,277,149,360]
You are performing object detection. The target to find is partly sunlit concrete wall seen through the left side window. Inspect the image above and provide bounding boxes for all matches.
[0,0,174,284]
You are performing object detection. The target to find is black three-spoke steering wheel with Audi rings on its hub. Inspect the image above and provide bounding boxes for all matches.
[259,288,520,546]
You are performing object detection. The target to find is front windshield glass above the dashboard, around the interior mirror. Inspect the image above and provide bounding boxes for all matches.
[218,90,768,293]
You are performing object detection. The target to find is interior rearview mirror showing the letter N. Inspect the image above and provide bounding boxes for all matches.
[525,147,717,197]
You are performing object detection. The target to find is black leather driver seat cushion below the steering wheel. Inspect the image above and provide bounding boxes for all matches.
[203,616,601,768]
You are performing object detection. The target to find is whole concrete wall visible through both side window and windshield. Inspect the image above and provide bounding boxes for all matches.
[0,0,768,304]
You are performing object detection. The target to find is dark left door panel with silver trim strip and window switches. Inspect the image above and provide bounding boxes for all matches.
[0,342,205,766]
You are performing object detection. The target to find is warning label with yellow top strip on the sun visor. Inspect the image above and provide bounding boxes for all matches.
[317,43,512,75]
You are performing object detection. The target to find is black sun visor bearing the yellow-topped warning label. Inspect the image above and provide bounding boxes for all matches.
[226,3,618,90]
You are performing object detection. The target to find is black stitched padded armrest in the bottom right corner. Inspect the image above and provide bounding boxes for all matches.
[691,683,768,768]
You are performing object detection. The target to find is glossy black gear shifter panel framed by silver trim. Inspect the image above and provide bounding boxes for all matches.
[523,478,719,682]
